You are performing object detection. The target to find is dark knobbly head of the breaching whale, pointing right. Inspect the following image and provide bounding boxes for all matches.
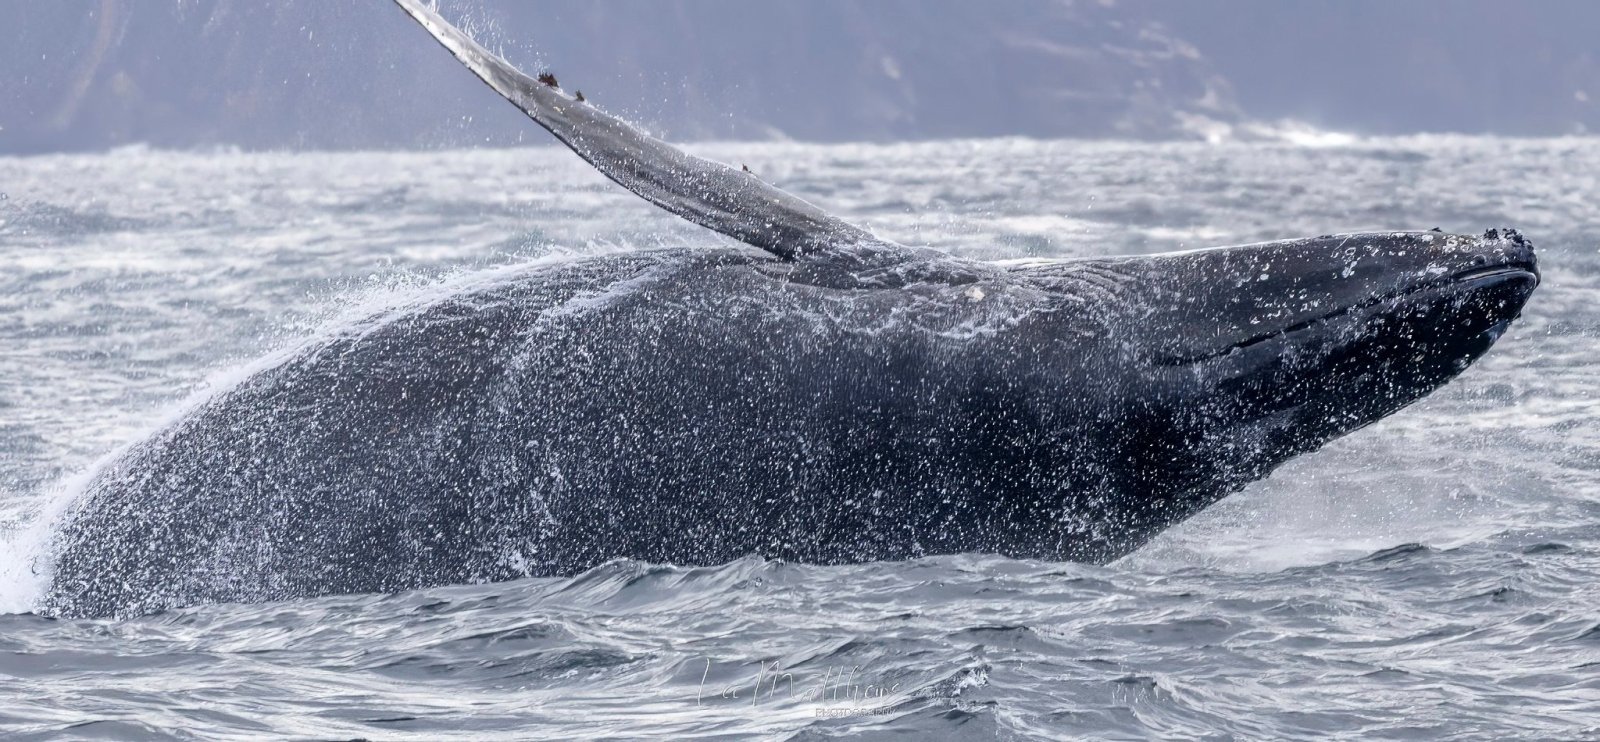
[1016,230,1539,552]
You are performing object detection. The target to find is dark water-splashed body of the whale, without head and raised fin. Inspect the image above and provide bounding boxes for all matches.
[45,249,1088,616]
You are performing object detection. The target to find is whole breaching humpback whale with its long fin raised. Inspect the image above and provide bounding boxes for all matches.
[42,0,1539,616]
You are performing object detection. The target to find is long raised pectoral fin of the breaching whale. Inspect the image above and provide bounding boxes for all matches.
[395,0,907,262]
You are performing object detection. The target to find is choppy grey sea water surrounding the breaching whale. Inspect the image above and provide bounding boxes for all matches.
[0,138,1600,739]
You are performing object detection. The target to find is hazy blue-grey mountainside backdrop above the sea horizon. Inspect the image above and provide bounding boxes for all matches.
[0,0,1600,154]
